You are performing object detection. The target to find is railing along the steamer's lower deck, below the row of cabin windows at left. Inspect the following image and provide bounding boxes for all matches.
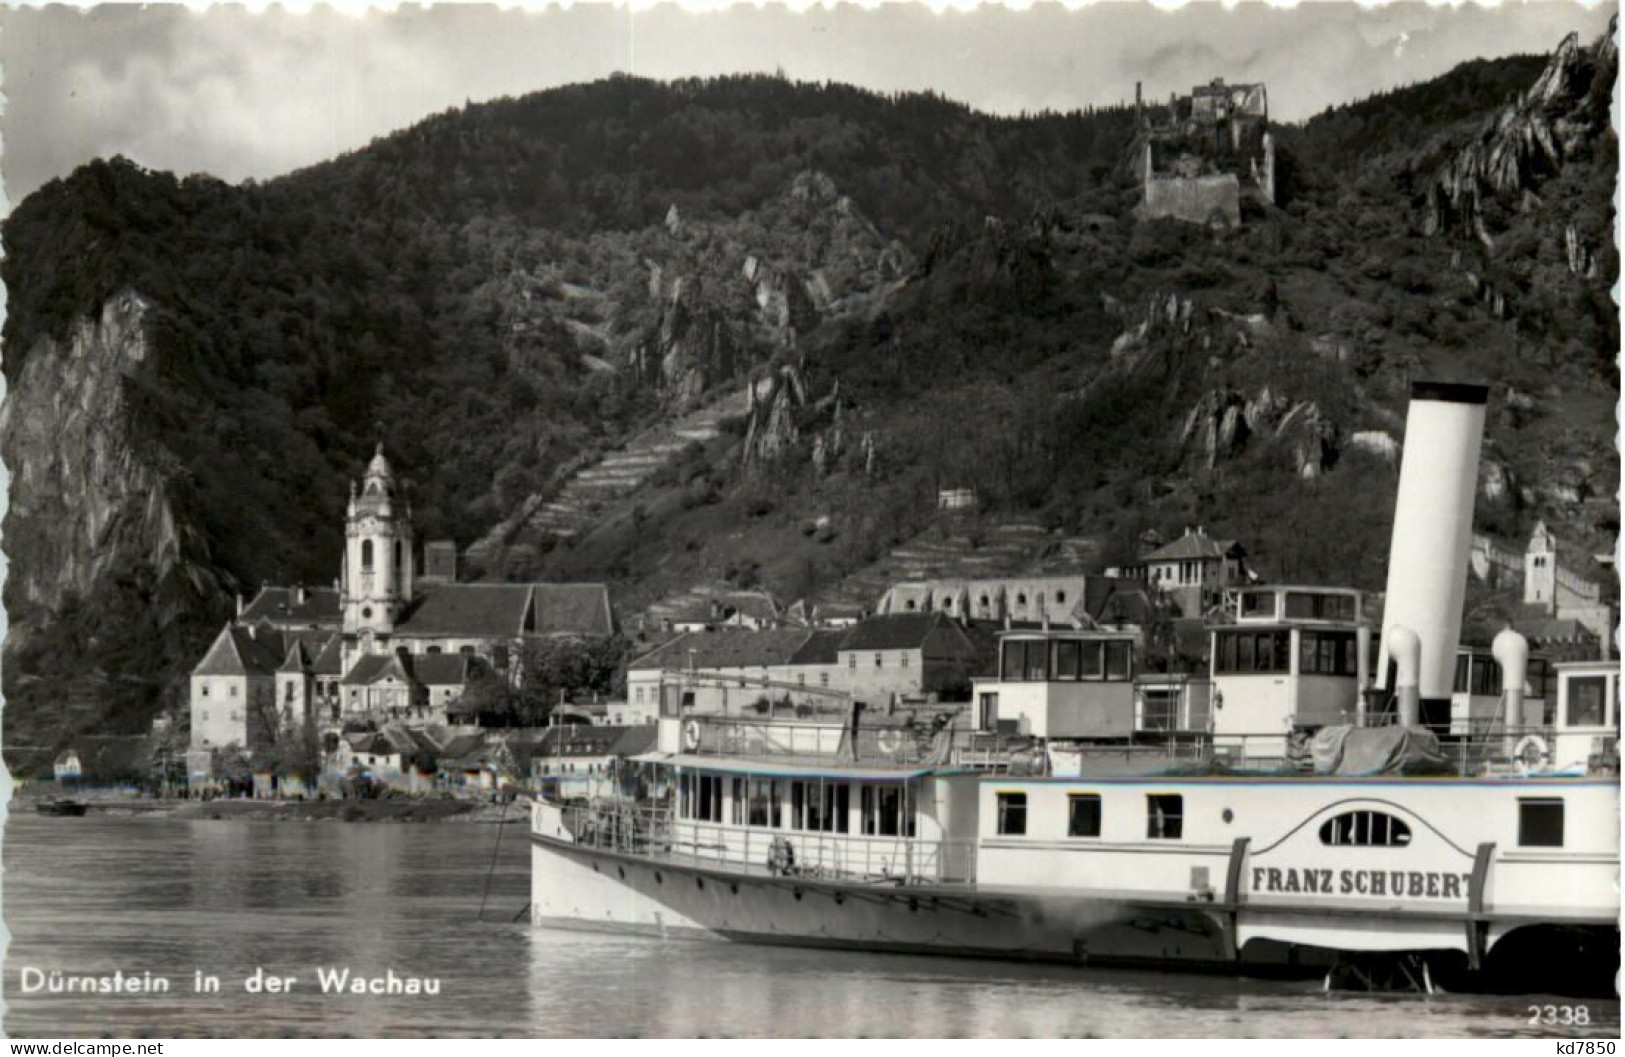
[559,802,975,885]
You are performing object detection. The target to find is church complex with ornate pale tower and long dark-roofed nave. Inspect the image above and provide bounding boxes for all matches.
[190,444,616,751]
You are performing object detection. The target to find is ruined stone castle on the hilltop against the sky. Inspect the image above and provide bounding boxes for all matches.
[1134,78,1276,228]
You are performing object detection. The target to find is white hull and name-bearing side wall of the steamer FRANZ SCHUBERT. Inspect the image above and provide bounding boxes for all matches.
[531,781,1617,987]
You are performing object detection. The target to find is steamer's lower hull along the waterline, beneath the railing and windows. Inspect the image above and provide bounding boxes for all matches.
[530,834,1619,995]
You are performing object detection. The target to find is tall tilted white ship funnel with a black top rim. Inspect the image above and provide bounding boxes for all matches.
[1378,382,1489,724]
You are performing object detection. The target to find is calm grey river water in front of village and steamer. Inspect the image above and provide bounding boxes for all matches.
[3,813,1619,1037]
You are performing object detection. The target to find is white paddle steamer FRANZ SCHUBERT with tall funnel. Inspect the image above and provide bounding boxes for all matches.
[531,384,1619,992]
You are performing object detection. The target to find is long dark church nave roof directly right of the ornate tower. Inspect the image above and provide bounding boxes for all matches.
[397,584,614,639]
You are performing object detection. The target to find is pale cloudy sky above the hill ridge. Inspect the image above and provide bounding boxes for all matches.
[0,0,1615,203]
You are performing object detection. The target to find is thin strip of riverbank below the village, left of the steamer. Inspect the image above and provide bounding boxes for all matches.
[20,797,525,824]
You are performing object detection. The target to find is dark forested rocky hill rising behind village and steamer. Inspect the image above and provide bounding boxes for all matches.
[0,26,1617,757]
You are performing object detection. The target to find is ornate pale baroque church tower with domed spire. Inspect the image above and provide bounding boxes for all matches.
[341,444,414,650]
